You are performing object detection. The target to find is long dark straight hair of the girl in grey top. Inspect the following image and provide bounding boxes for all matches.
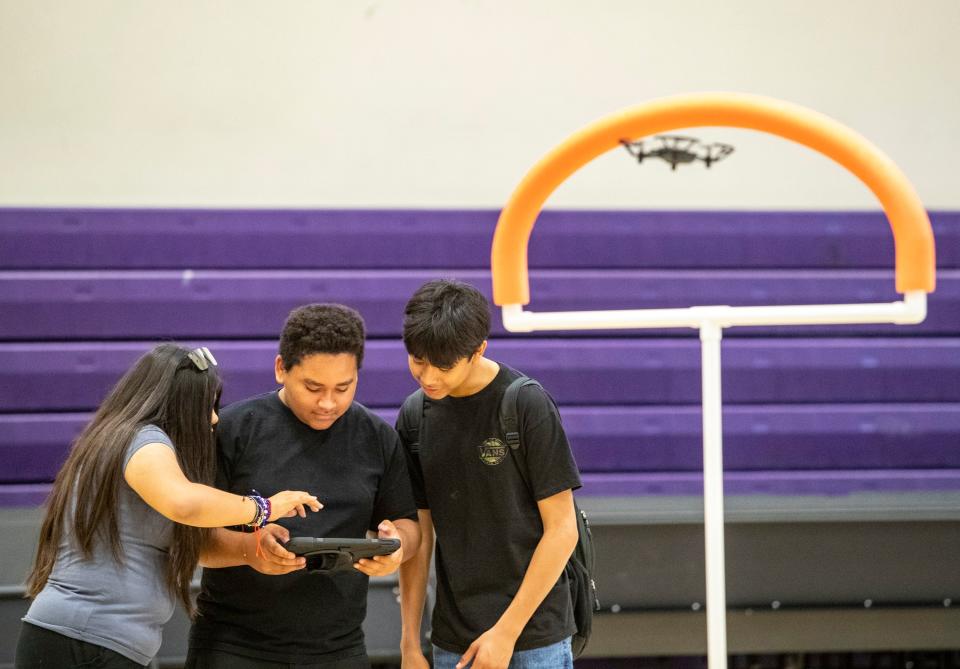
[27,344,222,615]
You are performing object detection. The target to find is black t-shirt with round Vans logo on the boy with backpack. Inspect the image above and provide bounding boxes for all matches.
[397,365,580,653]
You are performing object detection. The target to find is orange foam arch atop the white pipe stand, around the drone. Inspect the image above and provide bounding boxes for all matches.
[491,93,936,306]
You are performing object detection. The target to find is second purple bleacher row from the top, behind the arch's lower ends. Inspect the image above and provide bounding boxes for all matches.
[0,270,960,341]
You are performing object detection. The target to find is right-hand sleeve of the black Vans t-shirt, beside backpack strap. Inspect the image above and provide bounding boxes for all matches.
[517,385,581,501]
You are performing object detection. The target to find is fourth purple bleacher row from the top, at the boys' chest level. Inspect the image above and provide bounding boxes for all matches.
[0,403,960,483]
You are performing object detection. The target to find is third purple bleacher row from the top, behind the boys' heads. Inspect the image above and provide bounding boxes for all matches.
[0,338,960,412]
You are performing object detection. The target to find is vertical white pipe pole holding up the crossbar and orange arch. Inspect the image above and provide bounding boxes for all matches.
[700,321,727,669]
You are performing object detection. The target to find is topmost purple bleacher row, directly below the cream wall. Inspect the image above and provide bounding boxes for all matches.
[0,208,960,269]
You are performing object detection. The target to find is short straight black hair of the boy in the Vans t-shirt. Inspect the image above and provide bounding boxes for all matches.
[403,279,490,368]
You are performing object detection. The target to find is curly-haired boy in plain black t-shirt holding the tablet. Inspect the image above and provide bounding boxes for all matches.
[186,304,420,669]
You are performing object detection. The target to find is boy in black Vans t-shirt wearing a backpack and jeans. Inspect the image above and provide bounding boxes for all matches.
[397,280,580,669]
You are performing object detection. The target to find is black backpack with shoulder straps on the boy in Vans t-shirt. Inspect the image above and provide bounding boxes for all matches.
[400,376,600,658]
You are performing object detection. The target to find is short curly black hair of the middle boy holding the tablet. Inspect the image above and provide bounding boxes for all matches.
[280,304,366,371]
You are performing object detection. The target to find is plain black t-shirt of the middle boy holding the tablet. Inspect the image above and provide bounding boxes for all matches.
[190,392,417,663]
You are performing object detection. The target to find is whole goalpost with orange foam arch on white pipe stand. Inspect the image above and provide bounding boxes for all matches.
[491,93,935,669]
